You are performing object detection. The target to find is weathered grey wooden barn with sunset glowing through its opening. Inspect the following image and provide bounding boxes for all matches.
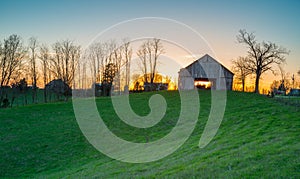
[178,54,234,90]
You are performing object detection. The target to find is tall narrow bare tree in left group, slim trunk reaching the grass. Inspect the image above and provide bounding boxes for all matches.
[29,37,38,103]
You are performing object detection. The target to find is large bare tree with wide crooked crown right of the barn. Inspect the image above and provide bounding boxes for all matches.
[237,30,289,93]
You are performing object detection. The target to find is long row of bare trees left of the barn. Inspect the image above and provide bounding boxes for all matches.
[0,34,164,106]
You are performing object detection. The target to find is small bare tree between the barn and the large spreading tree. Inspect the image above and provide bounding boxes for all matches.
[232,57,252,92]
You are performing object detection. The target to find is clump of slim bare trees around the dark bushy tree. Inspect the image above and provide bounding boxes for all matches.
[85,40,132,92]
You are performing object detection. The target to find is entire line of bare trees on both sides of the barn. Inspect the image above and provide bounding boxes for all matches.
[0,30,292,106]
